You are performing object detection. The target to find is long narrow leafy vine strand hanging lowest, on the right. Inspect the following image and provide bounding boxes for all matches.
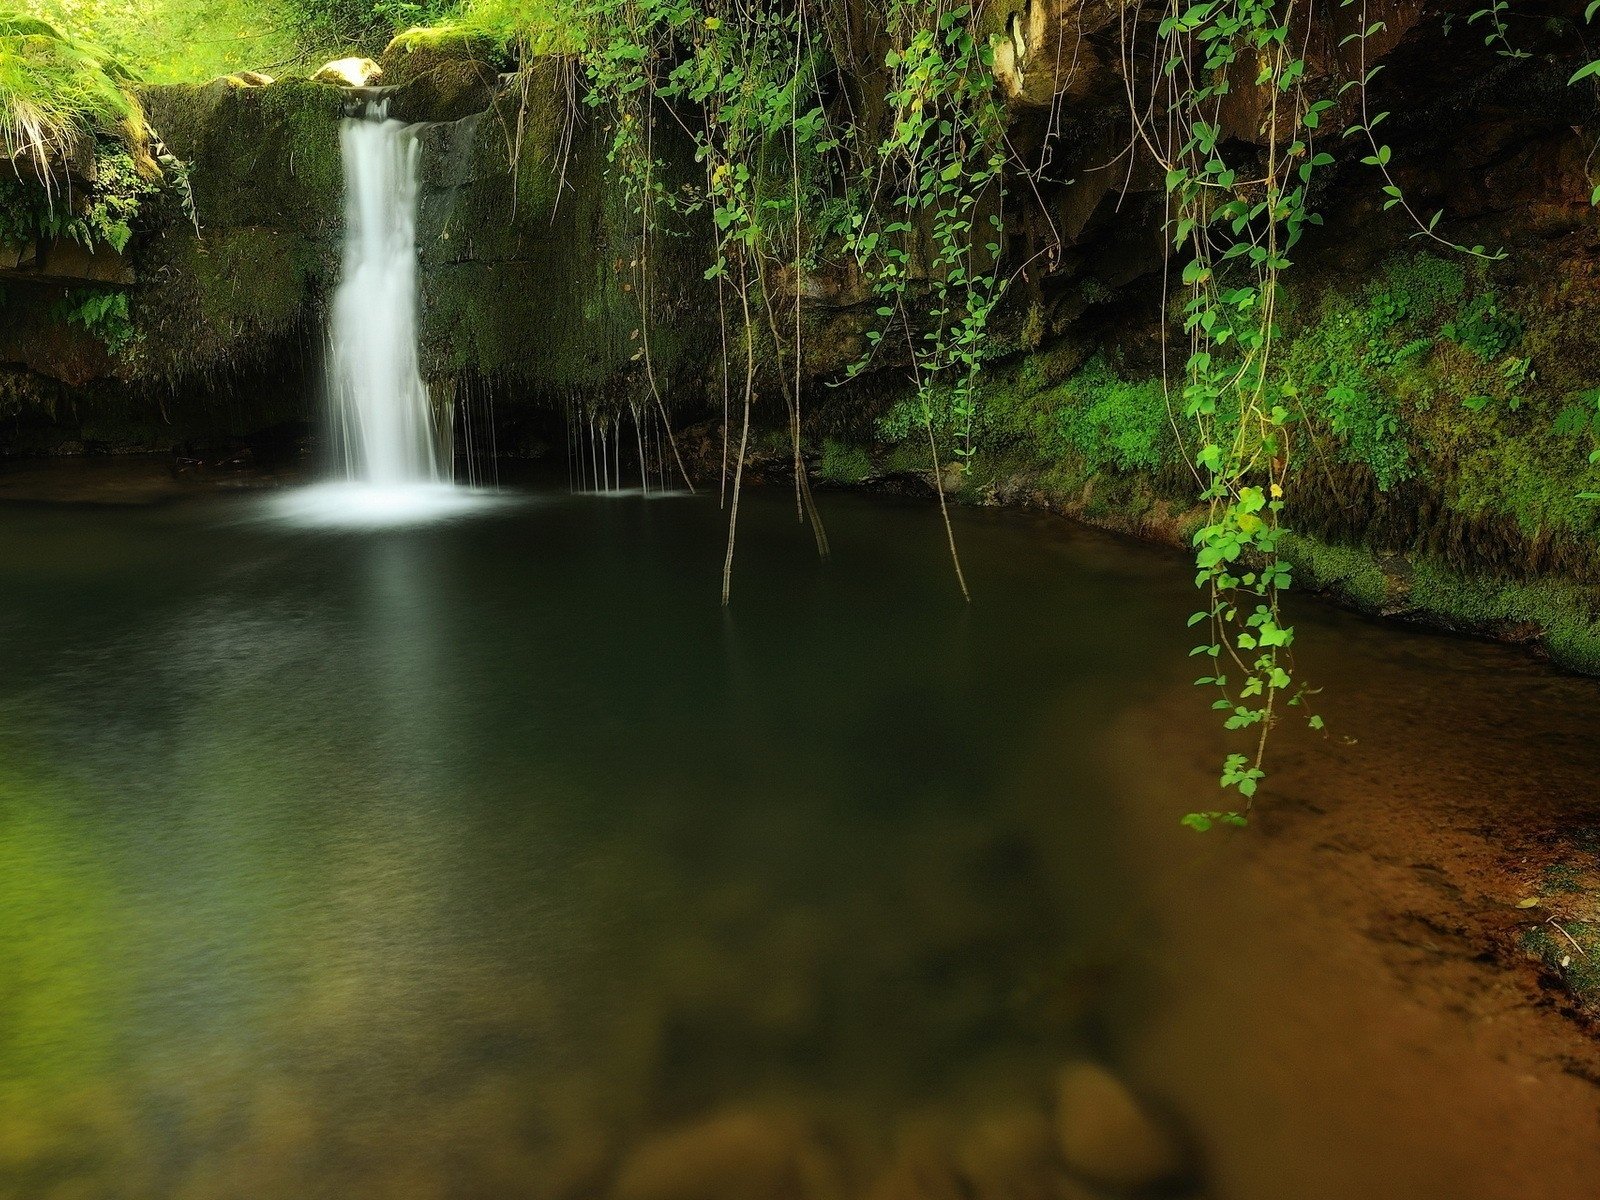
[1147,0,1337,810]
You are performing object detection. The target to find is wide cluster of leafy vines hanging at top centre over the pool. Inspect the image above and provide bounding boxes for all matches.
[550,0,1006,600]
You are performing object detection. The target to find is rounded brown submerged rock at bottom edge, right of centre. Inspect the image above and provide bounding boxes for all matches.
[1056,1062,1186,1190]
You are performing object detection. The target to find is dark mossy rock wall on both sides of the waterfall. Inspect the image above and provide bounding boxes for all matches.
[0,59,715,453]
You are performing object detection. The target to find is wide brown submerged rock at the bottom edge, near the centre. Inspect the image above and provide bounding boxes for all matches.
[611,1109,845,1200]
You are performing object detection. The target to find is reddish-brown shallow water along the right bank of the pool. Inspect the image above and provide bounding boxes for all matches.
[1109,608,1600,1200]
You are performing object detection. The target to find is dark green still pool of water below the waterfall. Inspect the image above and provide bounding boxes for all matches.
[0,493,1600,1200]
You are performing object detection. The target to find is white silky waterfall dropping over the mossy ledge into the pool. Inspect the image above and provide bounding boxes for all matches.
[328,101,450,488]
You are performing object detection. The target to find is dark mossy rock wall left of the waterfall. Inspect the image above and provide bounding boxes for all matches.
[0,80,346,454]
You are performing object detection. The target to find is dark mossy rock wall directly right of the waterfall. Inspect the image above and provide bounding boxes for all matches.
[419,59,715,402]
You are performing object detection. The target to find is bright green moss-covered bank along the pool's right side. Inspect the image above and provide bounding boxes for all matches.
[777,243,1600,674]
